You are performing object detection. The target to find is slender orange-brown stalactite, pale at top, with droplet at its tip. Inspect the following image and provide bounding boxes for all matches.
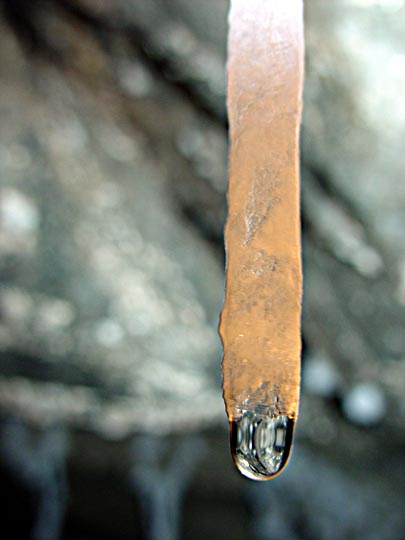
[220,0,304,479]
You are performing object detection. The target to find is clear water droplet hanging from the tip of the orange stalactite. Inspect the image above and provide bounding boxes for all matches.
[230,411,294,480]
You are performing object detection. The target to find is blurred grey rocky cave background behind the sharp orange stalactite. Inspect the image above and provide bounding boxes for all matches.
[0,0,405,540]
